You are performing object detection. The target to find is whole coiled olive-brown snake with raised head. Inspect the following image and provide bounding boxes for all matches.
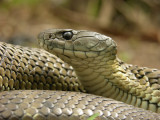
[0,29,160,120]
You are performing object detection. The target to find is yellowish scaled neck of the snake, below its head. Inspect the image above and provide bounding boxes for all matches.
[70,55,148,101]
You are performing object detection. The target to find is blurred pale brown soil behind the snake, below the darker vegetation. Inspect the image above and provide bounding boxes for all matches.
[0,3,160,69]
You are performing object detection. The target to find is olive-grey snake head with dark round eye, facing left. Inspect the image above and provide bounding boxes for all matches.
[38,29,117,64]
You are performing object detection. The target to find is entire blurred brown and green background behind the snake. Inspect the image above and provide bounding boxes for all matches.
[0,0,160,69]
